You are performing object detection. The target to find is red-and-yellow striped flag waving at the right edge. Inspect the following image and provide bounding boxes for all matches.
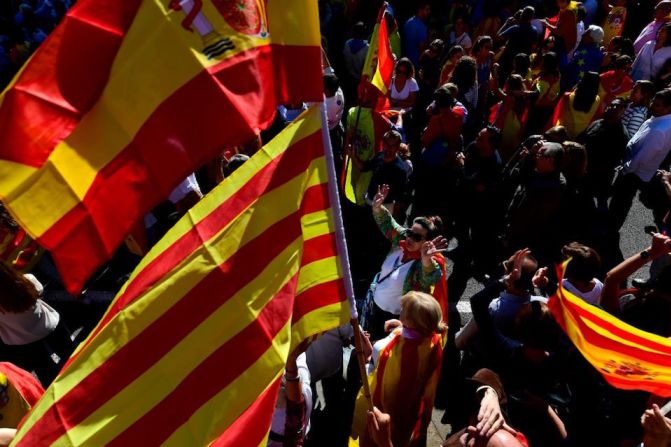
[548,264,671,397]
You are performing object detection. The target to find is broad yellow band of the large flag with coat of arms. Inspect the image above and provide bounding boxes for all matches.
[0,0,320,237]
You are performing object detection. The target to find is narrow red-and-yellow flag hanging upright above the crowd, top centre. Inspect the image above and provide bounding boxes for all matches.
[359,2,394,110]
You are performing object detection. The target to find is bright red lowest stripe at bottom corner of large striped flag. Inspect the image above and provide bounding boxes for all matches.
[210,378,282,447]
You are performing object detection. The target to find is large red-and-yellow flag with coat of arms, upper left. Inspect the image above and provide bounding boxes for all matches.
[0,0,322,292]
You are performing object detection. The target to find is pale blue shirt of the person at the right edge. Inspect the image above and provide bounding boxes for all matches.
[622,114,671,182]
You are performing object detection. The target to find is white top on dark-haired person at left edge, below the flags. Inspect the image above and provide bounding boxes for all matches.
[0,274,60,345]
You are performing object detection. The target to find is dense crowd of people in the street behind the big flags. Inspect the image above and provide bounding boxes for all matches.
[0,0,671,447]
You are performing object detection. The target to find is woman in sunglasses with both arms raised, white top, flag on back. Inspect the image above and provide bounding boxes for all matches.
[364,185,447,340]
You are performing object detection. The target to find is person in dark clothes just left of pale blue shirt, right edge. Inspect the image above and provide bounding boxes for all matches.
[577,99,629,211]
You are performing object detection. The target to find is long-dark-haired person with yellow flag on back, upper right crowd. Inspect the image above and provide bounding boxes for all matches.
[552,71,602,139]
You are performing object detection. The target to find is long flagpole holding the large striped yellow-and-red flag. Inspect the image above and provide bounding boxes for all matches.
[319,101,373,411]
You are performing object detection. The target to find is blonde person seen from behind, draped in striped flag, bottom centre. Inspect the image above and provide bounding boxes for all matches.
[352,291,447,446]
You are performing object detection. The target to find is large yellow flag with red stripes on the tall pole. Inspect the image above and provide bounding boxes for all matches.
[13,106,350,446]
